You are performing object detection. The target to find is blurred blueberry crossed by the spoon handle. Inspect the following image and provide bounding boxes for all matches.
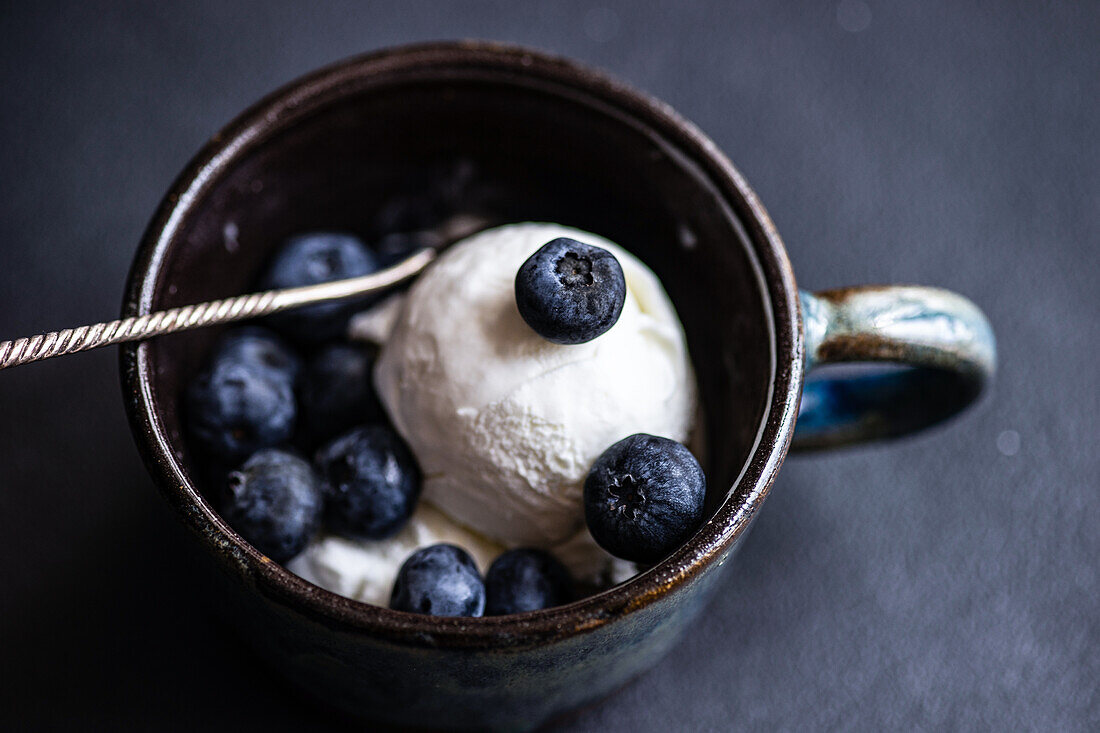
[260,232,380,343]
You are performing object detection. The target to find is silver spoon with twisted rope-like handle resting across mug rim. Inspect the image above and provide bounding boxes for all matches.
[0,249,436,369]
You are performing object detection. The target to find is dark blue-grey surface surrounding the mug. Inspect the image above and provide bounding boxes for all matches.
[0,0,1100,731]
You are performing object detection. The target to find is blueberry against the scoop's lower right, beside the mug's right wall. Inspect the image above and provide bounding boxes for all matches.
[584,433,706,564]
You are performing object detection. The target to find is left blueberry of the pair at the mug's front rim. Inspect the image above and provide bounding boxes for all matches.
[389,545,485,616]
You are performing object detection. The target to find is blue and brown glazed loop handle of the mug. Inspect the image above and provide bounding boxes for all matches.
[791,285,997,450]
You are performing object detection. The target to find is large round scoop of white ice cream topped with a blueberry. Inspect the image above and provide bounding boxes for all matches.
[375,223,695,548]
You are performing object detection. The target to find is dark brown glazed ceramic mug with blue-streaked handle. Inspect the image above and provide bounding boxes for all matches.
[121,43,994,729]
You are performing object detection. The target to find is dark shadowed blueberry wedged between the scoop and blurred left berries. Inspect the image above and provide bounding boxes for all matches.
[298,343,384,446]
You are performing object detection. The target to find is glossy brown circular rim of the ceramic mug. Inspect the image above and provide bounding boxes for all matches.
[119,41,804,648]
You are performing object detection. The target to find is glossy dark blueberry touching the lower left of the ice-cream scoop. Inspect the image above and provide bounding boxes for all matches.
[317,425,420,539]
